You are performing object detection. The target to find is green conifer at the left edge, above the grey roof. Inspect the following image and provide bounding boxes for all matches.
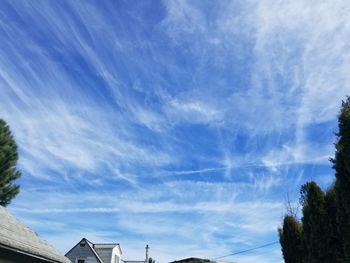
[0,119,21,206]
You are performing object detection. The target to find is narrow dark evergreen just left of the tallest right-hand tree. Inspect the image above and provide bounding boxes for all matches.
[323,187,343,263]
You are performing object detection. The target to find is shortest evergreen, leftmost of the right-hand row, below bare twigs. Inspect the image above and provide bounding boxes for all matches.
[278,215,303,263]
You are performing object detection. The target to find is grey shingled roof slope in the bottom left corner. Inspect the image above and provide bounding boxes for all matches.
[0,206,71,263]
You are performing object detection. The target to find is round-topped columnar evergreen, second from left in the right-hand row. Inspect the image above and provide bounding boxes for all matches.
[300,182,328,263]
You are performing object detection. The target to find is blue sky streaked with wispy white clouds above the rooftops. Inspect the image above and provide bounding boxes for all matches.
[0,0,350,263]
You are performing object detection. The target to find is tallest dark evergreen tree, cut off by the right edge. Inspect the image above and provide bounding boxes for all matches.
[332,97,350,262]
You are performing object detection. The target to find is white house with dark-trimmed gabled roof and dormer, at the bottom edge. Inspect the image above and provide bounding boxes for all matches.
[65,238,122,263]
